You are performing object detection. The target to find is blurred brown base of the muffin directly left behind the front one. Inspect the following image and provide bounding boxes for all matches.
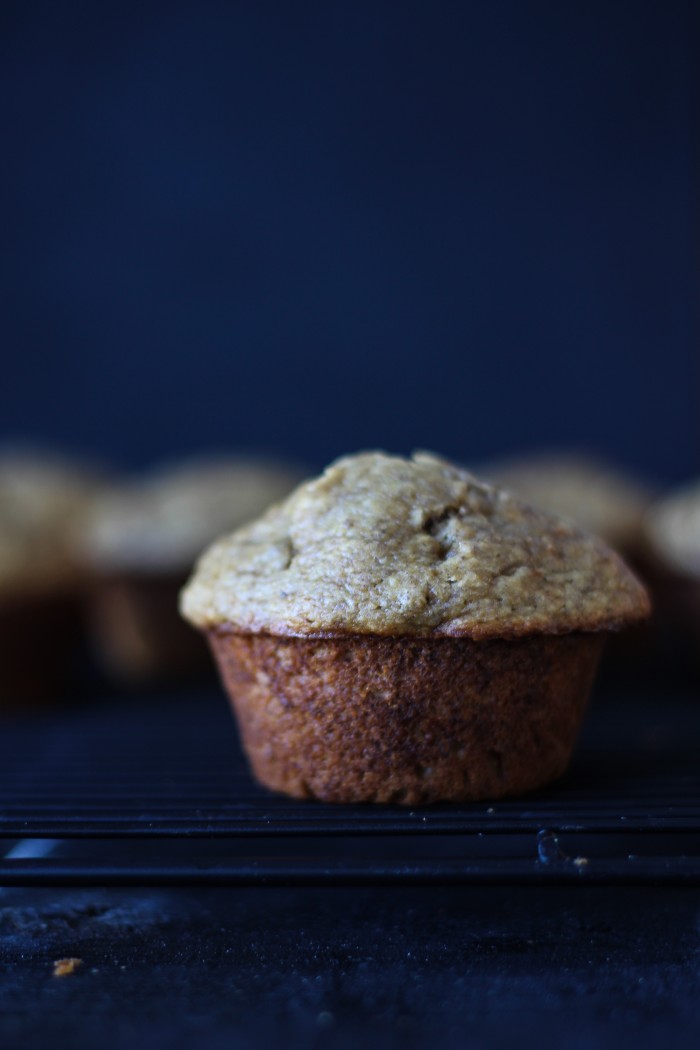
[88,573,209,686]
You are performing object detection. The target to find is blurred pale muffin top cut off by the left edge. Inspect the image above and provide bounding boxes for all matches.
[0,449,98,593]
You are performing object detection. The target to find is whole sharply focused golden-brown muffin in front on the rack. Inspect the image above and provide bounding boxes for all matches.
[181,453,649,805]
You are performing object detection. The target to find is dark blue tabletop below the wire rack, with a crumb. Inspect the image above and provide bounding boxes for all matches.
[0,887,700,1050]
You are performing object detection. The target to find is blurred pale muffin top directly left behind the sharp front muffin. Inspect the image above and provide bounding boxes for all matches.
[81,456,302,572]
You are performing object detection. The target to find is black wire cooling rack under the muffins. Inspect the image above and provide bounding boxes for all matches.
[0,692,700,886]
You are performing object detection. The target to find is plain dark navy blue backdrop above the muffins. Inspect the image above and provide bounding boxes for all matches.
[0,0,700,480]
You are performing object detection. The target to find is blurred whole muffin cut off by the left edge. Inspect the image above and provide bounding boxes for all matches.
[0,448,100,709]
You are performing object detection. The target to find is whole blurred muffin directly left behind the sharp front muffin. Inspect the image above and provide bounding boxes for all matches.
[81,456,303,686]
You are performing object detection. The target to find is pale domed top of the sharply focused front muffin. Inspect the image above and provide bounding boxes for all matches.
[181,453,649,638]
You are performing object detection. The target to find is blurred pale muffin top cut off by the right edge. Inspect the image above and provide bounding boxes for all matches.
[644,481,700,579]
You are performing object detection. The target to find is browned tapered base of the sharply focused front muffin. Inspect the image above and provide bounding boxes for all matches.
[209,629,604,805]
